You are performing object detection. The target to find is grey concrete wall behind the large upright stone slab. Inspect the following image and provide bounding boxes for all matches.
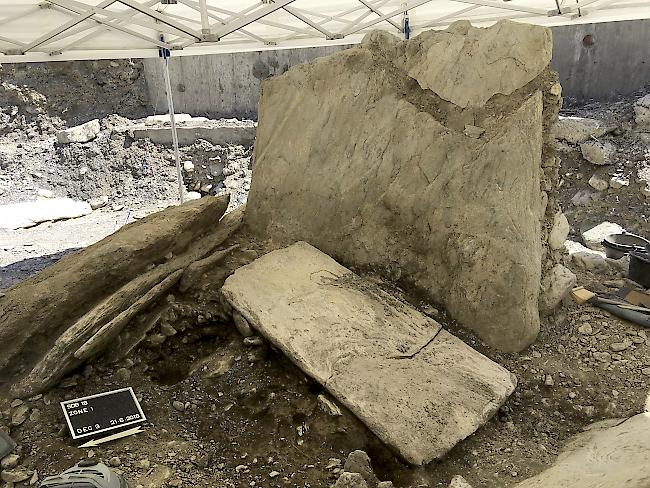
[144,20,650,118]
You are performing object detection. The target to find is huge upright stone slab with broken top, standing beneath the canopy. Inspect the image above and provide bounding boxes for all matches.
[246,22,561,351]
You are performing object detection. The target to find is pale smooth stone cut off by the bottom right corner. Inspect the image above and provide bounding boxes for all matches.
[516,413,650,488]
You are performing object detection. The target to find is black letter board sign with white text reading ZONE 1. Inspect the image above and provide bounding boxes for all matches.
[61,388,147,439]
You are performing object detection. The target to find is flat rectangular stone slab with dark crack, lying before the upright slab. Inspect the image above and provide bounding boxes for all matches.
[222,242,516,465]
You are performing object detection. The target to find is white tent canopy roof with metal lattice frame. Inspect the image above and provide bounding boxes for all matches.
[0,0,650,63]
